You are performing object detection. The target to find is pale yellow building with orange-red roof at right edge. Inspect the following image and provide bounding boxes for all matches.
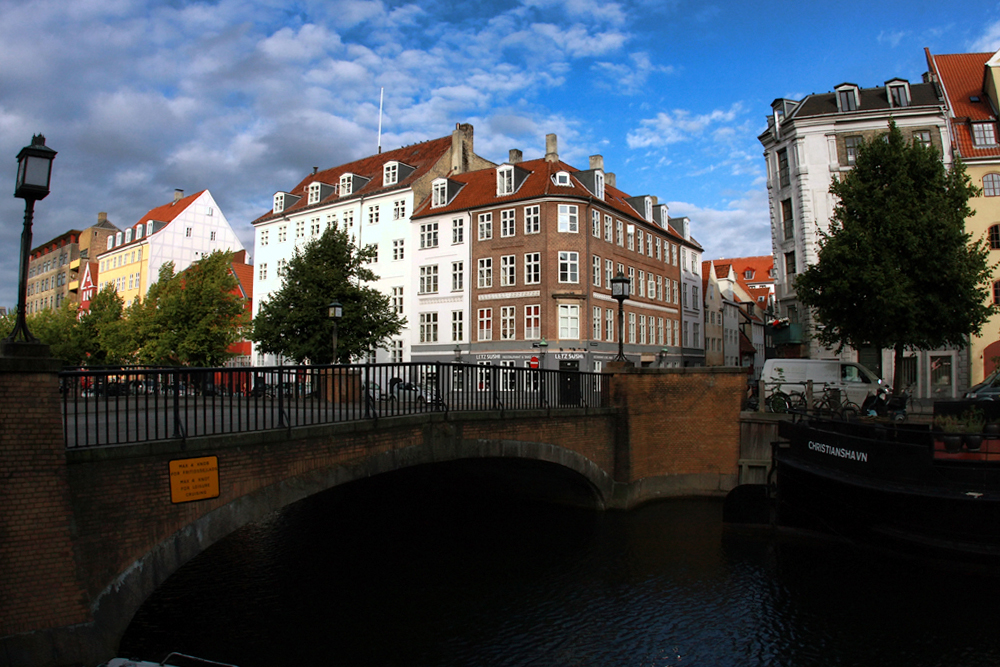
[925,49,1000,385]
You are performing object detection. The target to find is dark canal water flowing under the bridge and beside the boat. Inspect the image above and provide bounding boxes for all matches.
[119,464,1000,667]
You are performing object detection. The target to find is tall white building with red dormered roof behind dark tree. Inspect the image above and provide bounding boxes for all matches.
[253,124,492,365]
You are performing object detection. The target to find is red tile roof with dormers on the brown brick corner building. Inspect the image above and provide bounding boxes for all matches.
[410,159,700,247]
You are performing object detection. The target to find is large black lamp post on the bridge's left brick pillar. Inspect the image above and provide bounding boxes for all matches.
[4,134,56,343]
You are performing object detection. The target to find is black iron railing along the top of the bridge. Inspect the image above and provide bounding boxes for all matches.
[59,363,608,448]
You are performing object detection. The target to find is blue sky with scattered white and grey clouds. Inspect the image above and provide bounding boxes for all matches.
[0,0,1000,308]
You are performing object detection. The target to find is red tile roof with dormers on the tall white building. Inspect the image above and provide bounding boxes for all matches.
[254,135,452,222]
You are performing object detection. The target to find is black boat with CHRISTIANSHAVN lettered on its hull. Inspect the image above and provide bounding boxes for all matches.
[726,401,1000,565]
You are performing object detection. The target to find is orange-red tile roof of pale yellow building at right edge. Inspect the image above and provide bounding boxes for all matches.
[924,49,1000,158]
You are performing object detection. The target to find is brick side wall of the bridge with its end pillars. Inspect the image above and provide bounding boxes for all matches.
[0,359,745,667]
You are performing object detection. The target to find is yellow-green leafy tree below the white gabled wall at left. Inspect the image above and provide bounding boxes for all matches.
[128,251,249,367]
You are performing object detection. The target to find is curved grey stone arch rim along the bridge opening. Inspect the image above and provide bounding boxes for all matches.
[86,428,615,650]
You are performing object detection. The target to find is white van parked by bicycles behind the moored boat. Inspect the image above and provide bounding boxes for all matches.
[760,359,882,405]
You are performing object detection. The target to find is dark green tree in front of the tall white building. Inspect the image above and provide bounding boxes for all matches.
[251,227,405,364]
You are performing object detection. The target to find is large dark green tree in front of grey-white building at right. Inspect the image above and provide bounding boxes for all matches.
[795,121,993,392]
